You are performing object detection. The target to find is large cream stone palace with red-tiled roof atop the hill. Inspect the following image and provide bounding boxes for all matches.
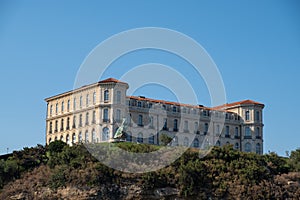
[45,78,264,154]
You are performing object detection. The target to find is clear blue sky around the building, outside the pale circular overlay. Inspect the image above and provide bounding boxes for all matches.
[0,0,300,155]
